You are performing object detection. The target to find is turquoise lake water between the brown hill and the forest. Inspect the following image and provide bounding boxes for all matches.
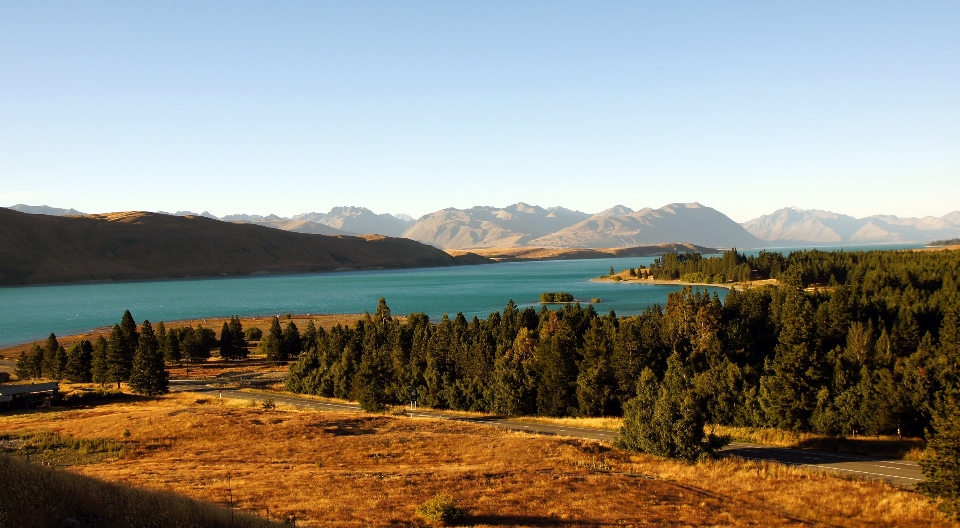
[0,245,918,346]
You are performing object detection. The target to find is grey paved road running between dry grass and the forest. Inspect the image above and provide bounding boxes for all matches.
[170,380,923,486]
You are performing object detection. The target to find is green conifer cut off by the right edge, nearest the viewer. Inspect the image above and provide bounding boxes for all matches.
[917,391,960,518]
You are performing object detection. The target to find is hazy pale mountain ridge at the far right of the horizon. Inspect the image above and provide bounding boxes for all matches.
[742,207,960,245]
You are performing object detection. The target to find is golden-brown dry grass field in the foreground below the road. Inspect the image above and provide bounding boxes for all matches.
[0,394,951,527]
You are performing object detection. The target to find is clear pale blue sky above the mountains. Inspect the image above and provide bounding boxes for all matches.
[0,1,960,221]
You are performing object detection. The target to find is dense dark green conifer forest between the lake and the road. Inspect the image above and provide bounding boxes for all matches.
[286,251,960,435]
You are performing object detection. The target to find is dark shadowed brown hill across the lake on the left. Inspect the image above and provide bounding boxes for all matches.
[0,208,489,285]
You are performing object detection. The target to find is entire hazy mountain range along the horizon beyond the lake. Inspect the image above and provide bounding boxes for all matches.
[10,202,960,250]
